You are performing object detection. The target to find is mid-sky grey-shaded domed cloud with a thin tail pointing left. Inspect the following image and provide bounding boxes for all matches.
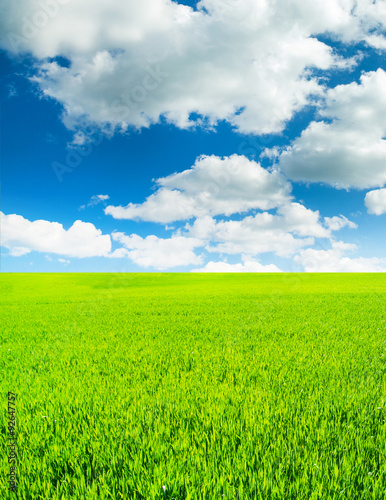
[105,155,291,223]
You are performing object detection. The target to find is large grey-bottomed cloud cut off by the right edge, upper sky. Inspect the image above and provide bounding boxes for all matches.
[279,69,386,189]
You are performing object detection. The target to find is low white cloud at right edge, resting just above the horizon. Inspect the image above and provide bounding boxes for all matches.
[294,242,386,273]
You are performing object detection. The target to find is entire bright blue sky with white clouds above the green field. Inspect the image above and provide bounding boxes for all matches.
[0,0,386,272]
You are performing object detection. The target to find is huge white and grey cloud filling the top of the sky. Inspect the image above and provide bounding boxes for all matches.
[0,0,376,134]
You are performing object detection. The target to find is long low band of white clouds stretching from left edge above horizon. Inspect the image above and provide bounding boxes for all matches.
[0,203,355,272]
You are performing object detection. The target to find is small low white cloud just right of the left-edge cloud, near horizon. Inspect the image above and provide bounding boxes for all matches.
[111,232,203,270]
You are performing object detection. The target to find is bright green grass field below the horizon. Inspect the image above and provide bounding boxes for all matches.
[0,274,386,500]
